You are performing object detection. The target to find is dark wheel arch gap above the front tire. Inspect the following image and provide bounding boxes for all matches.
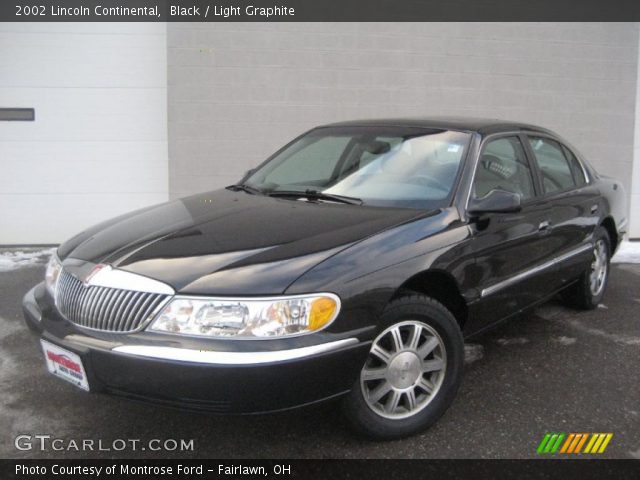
[391,270,469,330]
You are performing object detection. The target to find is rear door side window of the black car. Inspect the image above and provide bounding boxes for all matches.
[529,137,576,193]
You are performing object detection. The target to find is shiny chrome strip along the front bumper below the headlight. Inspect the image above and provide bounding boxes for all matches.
[112,338,360,365]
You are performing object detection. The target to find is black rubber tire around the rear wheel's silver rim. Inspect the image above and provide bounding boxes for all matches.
[563,227,611,310]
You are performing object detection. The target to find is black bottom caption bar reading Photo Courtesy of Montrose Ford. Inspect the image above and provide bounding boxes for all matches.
[0,459,640,480]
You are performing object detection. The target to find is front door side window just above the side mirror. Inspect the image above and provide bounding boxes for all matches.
[473,137,535,200]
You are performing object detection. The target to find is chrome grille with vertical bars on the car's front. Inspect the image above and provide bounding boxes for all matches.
[56,270,168,332]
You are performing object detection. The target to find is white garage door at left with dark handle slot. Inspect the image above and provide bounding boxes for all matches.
[0,23,168,245]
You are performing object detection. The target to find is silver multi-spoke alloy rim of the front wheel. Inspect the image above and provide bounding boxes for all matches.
[360,320,447,419]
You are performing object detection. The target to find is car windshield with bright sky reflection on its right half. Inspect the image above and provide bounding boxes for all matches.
[244,127,470,208]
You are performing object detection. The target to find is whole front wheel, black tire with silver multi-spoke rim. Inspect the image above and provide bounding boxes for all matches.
[343,294,464,440]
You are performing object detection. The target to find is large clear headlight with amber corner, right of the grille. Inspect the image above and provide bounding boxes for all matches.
[149,293,340,338]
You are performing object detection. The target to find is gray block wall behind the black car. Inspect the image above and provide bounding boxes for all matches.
[168,23,638,212]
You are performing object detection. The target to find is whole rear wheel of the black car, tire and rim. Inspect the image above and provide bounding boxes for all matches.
[565,227,611,310]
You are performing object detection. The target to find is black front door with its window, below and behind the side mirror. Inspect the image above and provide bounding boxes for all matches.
[467,135,554,333]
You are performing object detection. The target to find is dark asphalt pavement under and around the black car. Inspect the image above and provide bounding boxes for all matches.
[0,249,640,458]
